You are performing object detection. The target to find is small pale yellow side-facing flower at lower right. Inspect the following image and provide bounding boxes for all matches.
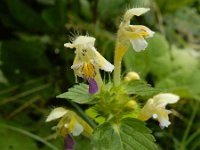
[138,93,179,128]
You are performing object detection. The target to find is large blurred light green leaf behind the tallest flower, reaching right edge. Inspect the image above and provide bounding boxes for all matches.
[124,34,200,99]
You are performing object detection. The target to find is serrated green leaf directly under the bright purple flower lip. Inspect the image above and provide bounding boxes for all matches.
[57,83,94,104]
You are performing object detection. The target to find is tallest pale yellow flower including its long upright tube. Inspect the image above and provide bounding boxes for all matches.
[114,8,154,86]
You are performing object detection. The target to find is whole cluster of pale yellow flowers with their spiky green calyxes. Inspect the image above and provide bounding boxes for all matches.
[46,8,179,149]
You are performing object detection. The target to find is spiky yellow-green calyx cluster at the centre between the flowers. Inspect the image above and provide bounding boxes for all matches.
[86,83,139,124]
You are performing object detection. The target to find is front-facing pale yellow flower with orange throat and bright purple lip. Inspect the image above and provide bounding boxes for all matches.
[64,36,114,93]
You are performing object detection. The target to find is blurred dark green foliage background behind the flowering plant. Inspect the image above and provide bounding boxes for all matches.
[0,0,200,150]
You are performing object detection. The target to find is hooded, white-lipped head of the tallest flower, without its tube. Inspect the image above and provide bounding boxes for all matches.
[118,8,154,52]
